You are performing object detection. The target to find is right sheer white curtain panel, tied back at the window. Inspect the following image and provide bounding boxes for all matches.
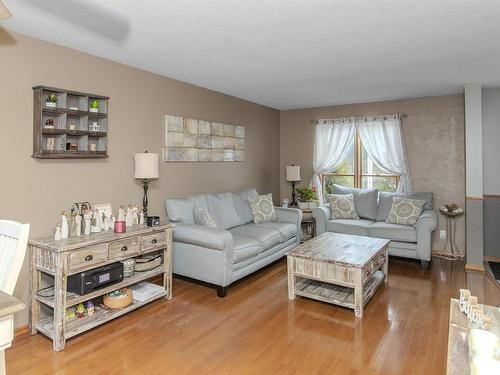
[355,115,412,193]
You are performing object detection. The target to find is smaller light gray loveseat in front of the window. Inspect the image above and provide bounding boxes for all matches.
[312,185,437,268]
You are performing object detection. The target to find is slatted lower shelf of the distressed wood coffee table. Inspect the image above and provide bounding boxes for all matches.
[295,271,385,309]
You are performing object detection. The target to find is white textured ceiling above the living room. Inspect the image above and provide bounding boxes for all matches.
[0,0,500,109]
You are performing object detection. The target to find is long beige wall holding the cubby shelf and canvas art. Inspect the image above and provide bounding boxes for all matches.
[0,29,279,326]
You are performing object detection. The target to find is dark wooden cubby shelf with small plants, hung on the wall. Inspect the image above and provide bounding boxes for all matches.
[32,86,109,159]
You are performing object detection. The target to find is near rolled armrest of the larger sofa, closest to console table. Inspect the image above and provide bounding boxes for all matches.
[173,222,234,251]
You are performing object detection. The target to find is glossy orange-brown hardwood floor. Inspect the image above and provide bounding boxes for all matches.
[6,259,500,375]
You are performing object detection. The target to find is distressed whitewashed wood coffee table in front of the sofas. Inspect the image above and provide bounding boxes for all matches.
[287,232,390,318]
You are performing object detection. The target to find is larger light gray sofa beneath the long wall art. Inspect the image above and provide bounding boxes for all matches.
[166,189,302,297]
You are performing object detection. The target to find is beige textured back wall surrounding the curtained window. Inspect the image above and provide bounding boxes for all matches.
[280,95,465,252]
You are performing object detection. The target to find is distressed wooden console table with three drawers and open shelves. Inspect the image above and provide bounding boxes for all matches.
[29,224,173,351]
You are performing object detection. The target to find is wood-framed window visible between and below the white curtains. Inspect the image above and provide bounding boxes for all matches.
[321,134,399,194]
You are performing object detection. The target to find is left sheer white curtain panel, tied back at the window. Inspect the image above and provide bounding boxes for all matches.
[311,120,355,204]
